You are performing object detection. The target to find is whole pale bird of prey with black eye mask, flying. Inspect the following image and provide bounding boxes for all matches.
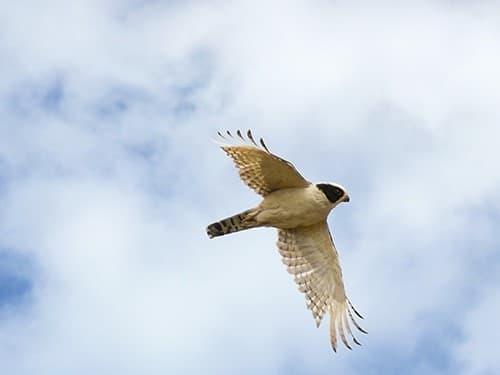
[207,130,366,352]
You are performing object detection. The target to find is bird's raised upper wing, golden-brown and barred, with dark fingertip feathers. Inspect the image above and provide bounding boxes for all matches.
[218,130,310,197]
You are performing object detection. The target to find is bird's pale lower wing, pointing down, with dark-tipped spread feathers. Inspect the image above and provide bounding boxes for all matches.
[277,221,366,351]
